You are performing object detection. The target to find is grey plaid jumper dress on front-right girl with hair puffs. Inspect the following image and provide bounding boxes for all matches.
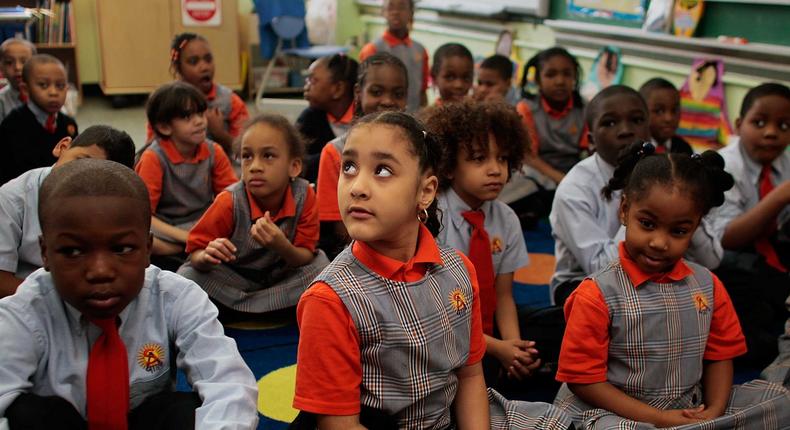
[554,259,790,430]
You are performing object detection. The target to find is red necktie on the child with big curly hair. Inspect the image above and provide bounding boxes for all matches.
[461,211,496,336]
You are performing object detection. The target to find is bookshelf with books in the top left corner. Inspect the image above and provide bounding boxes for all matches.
[0,0,82,99]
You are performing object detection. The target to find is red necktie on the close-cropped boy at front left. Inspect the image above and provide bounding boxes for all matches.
[87,318,129,430]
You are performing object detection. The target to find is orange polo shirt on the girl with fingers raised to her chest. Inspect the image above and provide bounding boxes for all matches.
[186,185,319,253]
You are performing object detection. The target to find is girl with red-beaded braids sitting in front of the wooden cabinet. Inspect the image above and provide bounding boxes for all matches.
[147,33,250,160]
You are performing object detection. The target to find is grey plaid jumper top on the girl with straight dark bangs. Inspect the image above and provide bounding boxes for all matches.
[147,139,215,240]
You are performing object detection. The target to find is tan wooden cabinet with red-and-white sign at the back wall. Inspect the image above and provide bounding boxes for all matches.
[96,0,242,94]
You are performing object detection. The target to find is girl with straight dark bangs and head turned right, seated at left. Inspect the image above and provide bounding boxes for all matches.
[135,81,237,262]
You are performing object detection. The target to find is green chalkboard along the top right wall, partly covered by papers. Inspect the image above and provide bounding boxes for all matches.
[549,0,790,45]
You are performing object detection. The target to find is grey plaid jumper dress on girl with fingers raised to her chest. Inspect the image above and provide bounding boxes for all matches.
[178,178,329,313]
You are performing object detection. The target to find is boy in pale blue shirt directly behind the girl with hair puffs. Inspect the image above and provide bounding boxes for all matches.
[549,85,723,306]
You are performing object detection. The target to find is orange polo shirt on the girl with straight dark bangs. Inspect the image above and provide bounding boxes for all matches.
[134,139,238,213]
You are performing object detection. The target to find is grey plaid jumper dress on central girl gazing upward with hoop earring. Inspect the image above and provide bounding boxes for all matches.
[316,246,570,430]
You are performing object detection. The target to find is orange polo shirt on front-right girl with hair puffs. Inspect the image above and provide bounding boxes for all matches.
[557,242,746,384]
